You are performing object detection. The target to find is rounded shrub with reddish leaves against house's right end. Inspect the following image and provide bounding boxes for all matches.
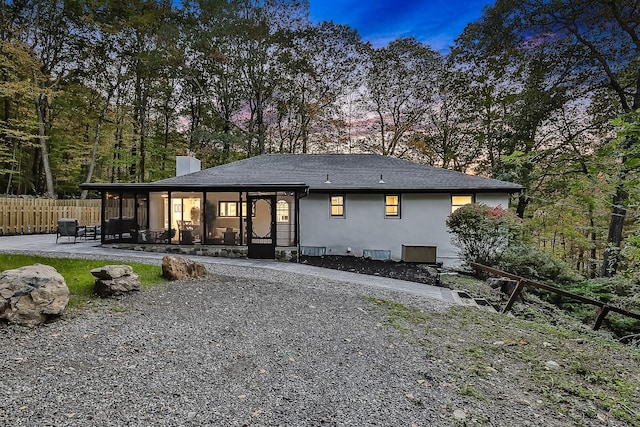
[446,203,520,265]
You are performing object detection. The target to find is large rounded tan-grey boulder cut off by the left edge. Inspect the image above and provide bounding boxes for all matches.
[0,264,69,327]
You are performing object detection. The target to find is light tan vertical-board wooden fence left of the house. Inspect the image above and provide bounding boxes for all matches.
[0,197,101,236]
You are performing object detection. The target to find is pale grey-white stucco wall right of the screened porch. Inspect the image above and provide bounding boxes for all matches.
[300,193,509,265]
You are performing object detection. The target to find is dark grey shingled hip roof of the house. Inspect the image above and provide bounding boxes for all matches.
[158,154,522,192]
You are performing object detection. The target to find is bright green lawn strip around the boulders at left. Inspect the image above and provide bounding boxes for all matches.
[0,254,166,307]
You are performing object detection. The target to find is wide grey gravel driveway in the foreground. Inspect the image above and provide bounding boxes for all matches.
[0,265,455,426]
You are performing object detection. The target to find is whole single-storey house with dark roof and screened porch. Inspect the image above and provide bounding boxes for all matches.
[81,154,522,265]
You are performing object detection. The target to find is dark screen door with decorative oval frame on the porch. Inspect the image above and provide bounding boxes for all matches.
[247,196,276,259]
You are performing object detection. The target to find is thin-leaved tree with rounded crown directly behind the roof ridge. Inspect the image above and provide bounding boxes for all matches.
[275,22,362,153]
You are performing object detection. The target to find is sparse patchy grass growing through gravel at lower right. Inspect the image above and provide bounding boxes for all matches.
[370,298,640,425]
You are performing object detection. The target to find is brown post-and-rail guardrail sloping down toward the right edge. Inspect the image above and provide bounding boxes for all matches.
[471,262,640,331]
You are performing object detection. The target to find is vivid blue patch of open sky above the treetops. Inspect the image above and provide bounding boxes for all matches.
[310,0,493,52]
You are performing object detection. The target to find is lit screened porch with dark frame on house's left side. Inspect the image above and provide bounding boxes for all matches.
[83,183,307,259]
